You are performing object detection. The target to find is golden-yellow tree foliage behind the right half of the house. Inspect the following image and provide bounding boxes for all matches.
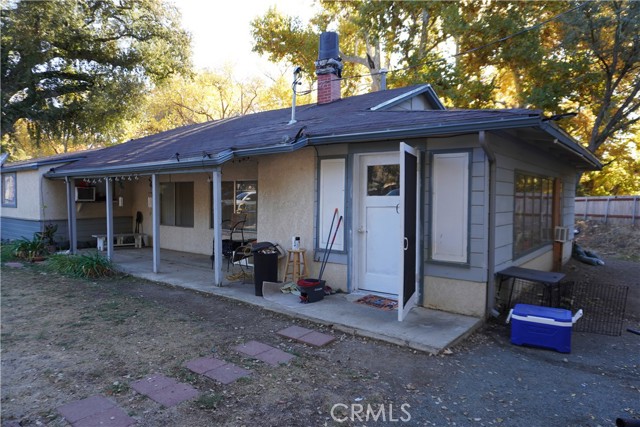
[253,0,640,196]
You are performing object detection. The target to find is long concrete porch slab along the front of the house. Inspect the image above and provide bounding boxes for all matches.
[113,248,482,353]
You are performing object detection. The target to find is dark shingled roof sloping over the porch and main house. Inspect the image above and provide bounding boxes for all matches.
[42,85,601,177]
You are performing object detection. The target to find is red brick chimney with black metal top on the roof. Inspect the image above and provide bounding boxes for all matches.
[316,32,342,105]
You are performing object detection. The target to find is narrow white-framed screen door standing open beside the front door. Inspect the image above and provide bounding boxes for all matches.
[398,142,419,321]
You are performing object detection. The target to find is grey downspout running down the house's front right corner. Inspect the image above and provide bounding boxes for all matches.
[478,130,500,317]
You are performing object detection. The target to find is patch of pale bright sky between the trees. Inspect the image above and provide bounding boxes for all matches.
[173,0,313,77]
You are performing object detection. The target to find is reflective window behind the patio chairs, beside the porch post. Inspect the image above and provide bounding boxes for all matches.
[209,181,258,231]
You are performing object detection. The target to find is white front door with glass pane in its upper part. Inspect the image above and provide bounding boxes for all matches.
[353,151,403,295]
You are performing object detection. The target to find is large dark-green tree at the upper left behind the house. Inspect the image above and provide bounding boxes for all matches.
[0,0,190,157]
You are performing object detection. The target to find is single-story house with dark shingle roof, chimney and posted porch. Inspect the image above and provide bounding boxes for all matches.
[2,32,601,319]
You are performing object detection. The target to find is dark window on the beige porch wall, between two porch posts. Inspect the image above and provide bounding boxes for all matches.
[160,182,194,227]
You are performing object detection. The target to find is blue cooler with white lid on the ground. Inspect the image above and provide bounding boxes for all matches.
[507,304,582,353]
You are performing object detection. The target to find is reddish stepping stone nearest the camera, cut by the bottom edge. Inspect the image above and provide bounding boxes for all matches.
[58,396,136,427]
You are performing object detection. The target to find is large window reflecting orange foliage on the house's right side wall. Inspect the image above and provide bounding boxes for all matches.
[513,172,553,258]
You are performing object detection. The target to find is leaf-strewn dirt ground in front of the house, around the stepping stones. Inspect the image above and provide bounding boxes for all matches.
[1,226,640,427]
